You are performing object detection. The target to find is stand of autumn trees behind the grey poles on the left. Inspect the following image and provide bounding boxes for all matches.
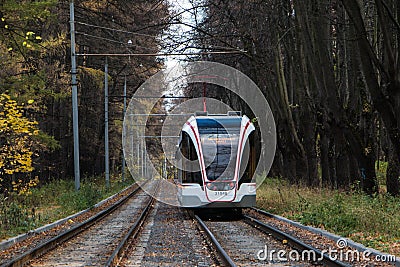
[0,0,168,181]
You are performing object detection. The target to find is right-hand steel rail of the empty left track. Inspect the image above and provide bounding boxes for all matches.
[105,183,160,266]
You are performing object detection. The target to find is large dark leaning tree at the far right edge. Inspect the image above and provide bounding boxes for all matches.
[341,0,400,195]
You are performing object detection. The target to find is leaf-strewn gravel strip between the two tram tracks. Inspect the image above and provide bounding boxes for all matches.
[121,202,216,267]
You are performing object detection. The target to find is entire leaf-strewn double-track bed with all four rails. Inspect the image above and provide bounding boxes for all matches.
[1,187,392,267]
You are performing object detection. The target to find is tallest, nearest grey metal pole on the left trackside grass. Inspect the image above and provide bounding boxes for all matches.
[69,0,81,190]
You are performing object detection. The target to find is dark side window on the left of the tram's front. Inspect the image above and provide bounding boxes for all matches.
[181,133,202,185]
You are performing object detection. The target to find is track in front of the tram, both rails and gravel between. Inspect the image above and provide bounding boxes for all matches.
[194,211,352,266]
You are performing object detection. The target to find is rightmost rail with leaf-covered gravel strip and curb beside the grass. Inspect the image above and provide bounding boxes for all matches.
[244,208,400,267]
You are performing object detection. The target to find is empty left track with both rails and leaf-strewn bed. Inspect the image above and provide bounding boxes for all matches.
[1,182,157,266]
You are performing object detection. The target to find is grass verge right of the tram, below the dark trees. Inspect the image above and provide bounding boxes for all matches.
[257,178,400,255]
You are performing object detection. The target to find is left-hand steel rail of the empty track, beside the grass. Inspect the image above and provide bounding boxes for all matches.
[1,183,141,267]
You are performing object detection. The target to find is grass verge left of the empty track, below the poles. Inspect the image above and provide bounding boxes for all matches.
[0,177,133,240]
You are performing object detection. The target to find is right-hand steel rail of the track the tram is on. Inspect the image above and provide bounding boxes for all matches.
[243,215,352,267]
